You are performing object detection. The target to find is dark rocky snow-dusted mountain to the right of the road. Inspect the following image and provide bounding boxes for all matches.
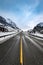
[28,22,43,34]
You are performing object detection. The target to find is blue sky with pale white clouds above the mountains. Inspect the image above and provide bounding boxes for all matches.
[0,0,43,30]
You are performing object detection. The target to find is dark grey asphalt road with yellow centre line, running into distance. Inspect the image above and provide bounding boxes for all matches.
[0,33,43,65]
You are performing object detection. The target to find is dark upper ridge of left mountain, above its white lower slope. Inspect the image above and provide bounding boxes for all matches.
[0,16,18,29]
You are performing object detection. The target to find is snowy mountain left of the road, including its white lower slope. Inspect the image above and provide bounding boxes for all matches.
[0,16,19,31]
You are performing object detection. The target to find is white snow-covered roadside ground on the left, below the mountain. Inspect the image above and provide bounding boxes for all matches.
[0,30,21,44]
